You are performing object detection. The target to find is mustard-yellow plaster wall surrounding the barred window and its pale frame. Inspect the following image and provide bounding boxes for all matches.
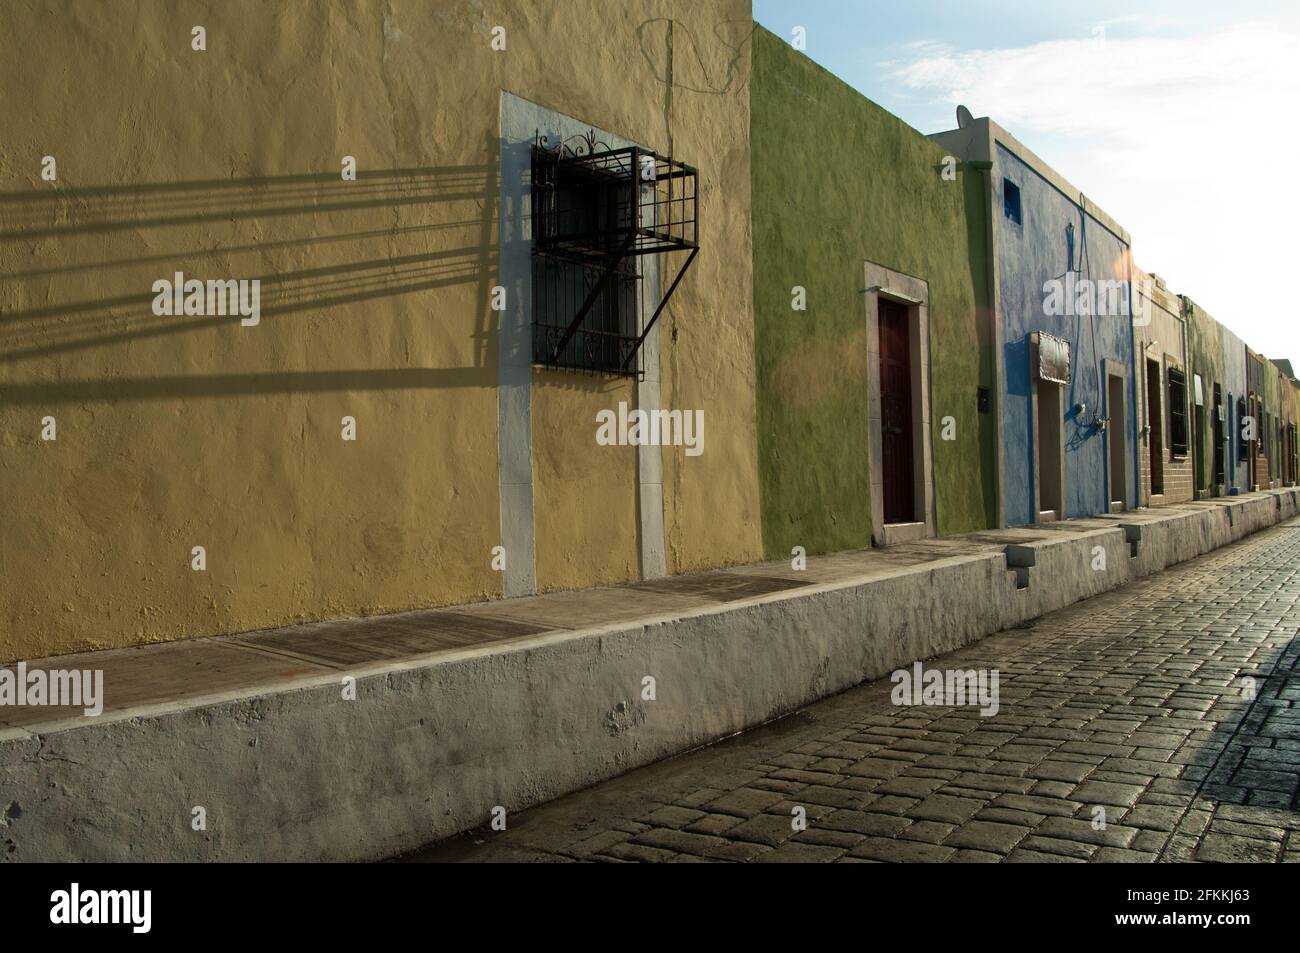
[0,0,759,659]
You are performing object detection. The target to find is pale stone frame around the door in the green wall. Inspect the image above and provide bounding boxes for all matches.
[863,261,935,546]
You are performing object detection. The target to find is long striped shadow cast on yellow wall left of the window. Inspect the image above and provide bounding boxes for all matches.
[0,144,499,404]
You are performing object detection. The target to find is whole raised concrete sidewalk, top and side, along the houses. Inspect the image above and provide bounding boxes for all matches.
[0,488,1300,859]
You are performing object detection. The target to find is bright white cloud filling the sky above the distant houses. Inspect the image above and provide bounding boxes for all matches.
[887,21,1300,358]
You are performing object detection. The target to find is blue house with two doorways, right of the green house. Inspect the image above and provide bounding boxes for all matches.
[932,114,1139,527]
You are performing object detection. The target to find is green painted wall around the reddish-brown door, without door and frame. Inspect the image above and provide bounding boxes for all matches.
[750,27,997,558]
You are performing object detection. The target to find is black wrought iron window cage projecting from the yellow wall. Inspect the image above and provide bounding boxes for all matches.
[532,137,699,376]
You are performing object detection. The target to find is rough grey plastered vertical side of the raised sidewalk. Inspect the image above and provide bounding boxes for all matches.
[0,489,1300,861]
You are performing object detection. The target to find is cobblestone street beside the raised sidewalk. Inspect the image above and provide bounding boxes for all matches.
[407,520,1300,862]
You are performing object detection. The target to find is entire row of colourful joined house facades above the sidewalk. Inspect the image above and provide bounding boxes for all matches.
[0,9,1300,662]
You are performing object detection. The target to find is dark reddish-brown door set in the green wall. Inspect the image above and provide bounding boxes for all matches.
[880,298,915,523]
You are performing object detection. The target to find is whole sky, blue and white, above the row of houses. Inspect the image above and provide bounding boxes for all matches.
[754,0,1300,368]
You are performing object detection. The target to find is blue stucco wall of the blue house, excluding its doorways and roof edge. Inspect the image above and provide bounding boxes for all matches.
[992,143,1138,527]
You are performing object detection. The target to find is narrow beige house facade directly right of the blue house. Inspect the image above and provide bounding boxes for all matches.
[1132,265,1193,506]
